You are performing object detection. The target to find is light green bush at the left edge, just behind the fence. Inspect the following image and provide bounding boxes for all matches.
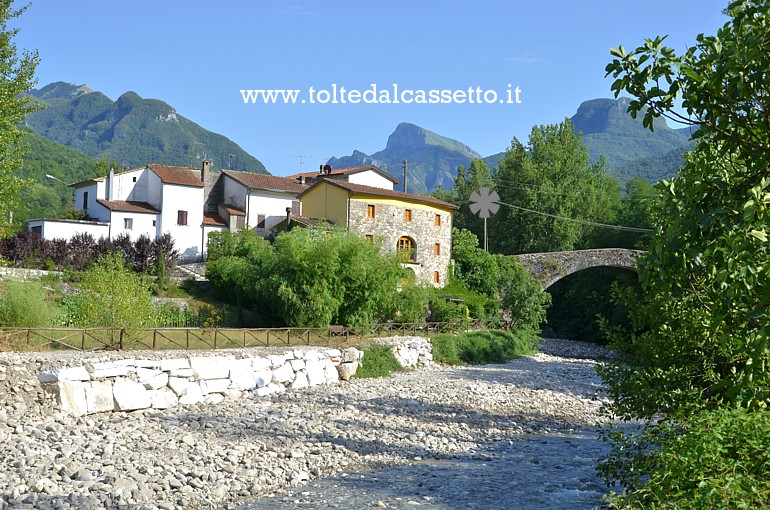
[0,280,56,328]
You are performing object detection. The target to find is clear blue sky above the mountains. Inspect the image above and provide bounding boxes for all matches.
[14,0,726,175]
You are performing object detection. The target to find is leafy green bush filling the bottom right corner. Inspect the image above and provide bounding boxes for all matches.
[613,408,770,509]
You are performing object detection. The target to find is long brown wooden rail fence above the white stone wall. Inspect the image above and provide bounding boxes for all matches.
[0,321,492,351]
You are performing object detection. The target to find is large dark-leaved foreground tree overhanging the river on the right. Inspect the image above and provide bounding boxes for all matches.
[600,0,770,500]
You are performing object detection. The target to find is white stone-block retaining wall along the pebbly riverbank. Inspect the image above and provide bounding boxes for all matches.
[37,348,363,416]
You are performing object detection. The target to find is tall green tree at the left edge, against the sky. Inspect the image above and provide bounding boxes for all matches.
[0,0,39,238]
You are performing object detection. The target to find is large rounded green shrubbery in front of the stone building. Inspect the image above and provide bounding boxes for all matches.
[206,228,408,327]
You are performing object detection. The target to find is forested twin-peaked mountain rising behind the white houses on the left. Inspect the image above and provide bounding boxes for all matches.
[24,82,267,173]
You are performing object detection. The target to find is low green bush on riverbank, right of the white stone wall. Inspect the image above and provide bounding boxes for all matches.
[431,330,538,365]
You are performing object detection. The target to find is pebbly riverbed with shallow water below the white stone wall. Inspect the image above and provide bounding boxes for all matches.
[0,340,604,509]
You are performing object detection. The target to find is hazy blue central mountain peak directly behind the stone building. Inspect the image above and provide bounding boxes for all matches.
[328,122,481,193]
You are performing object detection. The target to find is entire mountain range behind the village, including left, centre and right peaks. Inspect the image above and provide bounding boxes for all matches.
[19,82,692,223]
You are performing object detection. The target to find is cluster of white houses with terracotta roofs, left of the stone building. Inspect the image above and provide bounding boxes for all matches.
[28,161,307,261]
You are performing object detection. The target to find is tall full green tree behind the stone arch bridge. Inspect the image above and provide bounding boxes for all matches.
[490,119,617,254]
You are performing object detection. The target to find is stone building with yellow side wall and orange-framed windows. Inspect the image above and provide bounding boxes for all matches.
[298,178,457,287]
